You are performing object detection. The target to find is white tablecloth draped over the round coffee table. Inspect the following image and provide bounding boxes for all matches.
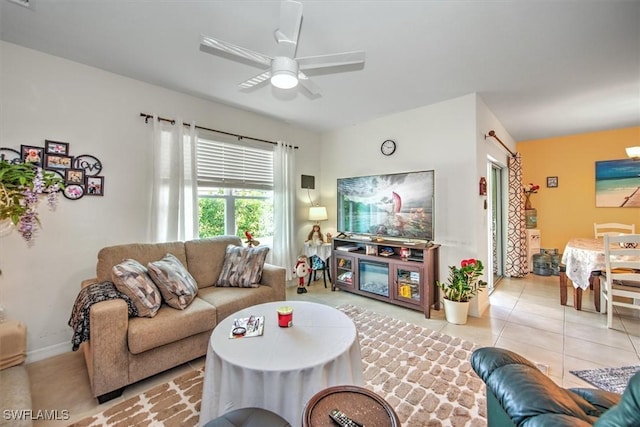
[200,301,364,427]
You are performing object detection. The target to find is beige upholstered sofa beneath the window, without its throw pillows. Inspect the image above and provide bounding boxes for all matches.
[80,236,286,403]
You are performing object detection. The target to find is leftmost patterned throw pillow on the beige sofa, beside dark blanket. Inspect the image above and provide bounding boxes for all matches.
[111,259,162,317]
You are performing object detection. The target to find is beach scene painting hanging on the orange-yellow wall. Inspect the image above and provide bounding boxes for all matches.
[596,159,640,208]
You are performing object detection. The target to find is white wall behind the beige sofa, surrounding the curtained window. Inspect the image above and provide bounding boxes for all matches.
[0,42,320,361]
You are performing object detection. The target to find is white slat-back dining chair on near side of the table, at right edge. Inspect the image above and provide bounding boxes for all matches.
[600,234,640,328]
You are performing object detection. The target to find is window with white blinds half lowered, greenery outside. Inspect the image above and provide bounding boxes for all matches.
[197,138,273,245]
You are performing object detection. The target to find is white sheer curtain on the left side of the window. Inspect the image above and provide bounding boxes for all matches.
[149,115,198,242]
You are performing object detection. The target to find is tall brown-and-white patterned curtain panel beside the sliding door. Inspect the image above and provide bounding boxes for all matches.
[505,153,528,277]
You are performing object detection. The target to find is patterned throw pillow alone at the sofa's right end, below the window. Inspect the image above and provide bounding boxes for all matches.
[216,245,269,288]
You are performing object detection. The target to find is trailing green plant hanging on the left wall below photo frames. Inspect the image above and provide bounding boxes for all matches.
[0,159,64,242]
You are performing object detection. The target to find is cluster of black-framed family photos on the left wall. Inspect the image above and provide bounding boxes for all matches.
[20,139,104,200]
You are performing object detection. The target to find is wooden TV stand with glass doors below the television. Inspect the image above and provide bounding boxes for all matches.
[331,237,440,318]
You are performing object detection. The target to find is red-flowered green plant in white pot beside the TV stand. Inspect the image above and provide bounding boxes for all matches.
[436,258,487,325]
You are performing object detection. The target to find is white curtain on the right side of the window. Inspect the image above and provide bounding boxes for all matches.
[272,141,296,280]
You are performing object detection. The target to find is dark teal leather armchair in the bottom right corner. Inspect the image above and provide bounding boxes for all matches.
[471,347,640,427]
